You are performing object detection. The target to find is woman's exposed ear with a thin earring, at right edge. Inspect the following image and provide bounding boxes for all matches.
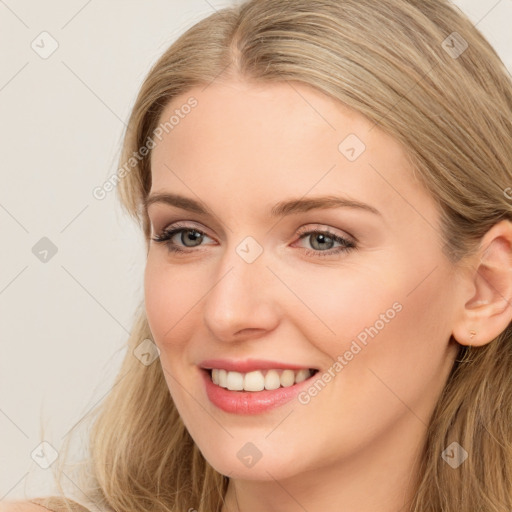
[452,220,512,346]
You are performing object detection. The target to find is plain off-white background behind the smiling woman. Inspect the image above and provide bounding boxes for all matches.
[0,0,512,500]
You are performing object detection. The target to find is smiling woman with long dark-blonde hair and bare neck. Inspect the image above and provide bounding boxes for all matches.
[8,0,512,512]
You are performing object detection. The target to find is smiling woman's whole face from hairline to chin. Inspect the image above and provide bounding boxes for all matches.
[145,82,460,480]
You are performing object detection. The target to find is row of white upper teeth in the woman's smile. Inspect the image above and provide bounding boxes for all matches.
[211,368,313,391]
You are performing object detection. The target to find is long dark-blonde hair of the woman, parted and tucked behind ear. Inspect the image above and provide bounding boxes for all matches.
[41,0,512,512]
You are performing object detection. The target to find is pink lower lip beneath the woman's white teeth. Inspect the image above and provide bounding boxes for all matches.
[201,370,316,414]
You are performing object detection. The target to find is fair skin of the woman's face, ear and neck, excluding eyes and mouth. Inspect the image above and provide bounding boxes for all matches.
[145,79,512,512]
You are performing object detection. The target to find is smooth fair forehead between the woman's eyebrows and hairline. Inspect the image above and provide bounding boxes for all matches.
[151,81,429,223]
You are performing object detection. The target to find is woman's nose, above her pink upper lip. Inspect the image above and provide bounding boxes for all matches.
[202,250,281,342]
